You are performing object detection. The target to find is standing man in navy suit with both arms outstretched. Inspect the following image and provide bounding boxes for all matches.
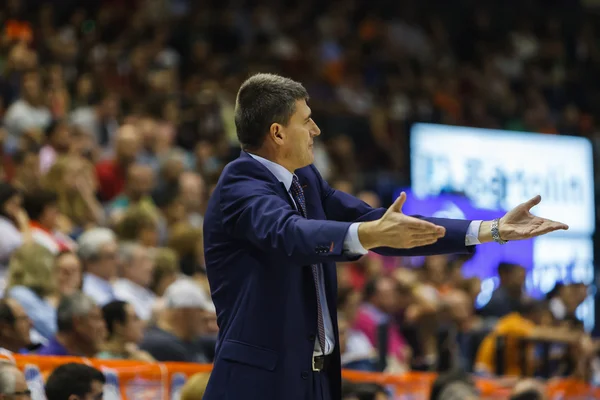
[204,74,567,400]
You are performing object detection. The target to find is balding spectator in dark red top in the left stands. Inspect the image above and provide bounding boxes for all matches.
[96,125,140,201]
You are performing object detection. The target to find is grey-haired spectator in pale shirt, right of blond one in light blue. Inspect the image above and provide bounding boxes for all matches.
[78,228,119,307]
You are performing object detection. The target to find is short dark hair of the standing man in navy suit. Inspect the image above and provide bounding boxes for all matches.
[235,74,308,149]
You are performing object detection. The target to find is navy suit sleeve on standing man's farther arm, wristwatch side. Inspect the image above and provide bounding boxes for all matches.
[313,166,474,256]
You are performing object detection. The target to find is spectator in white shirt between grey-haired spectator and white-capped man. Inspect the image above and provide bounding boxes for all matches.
[113,243,156,321]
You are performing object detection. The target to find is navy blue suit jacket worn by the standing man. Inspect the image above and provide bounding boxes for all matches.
[204,152,470,400]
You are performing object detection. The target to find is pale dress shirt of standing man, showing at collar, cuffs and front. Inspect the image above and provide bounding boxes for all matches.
[248,153,481,355]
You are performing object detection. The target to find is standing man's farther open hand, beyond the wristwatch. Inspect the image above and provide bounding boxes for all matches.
[499,195,569,240]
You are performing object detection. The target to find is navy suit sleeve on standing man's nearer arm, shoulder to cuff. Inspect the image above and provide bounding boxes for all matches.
[220,168,357,265]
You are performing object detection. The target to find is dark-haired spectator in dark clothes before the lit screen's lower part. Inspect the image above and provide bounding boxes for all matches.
[480,262,527,318]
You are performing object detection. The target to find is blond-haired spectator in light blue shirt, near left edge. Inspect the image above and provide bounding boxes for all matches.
[6,242,56,339]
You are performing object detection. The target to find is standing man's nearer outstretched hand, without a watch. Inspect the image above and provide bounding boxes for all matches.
[358,192,446,249]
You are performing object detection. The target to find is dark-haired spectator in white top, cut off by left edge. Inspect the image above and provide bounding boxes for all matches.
[0,182,31,266]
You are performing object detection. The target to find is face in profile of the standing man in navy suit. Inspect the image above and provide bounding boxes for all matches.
[278,100,321,170]
